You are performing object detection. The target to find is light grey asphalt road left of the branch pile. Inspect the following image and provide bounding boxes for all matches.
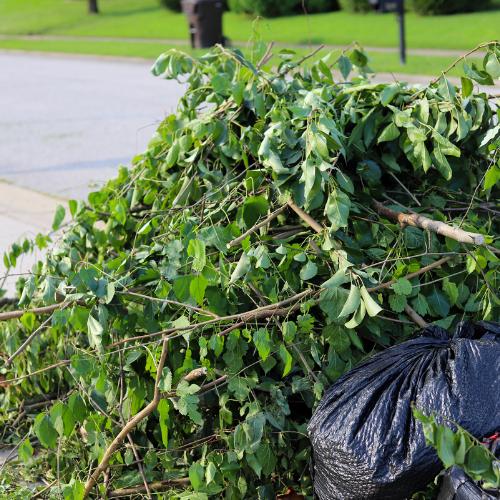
[0,52,185,198]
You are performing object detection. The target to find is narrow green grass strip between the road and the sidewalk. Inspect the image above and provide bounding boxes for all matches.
[0,38,468,76]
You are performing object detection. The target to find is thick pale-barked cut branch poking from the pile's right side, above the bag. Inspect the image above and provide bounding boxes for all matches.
[372,202,484,246]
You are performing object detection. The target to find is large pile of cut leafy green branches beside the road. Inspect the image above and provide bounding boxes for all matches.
[0,41,500,500]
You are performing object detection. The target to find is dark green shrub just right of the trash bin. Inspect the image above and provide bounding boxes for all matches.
[229,0,339,17]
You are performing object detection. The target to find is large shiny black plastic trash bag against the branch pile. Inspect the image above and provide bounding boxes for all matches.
[308,322,500,500]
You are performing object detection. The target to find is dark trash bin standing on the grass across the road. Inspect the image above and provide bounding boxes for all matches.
[181,0,228,49]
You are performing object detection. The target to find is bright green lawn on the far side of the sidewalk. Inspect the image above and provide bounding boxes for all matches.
[0,0,500,50]
